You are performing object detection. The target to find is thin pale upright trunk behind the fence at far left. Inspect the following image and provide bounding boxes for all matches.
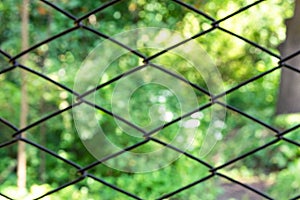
[17,0,29,193]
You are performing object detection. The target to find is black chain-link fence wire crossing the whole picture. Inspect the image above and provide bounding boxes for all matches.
[0,0,300,199]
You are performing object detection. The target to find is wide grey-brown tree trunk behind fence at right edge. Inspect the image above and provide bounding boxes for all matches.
[277,0,300,114]
